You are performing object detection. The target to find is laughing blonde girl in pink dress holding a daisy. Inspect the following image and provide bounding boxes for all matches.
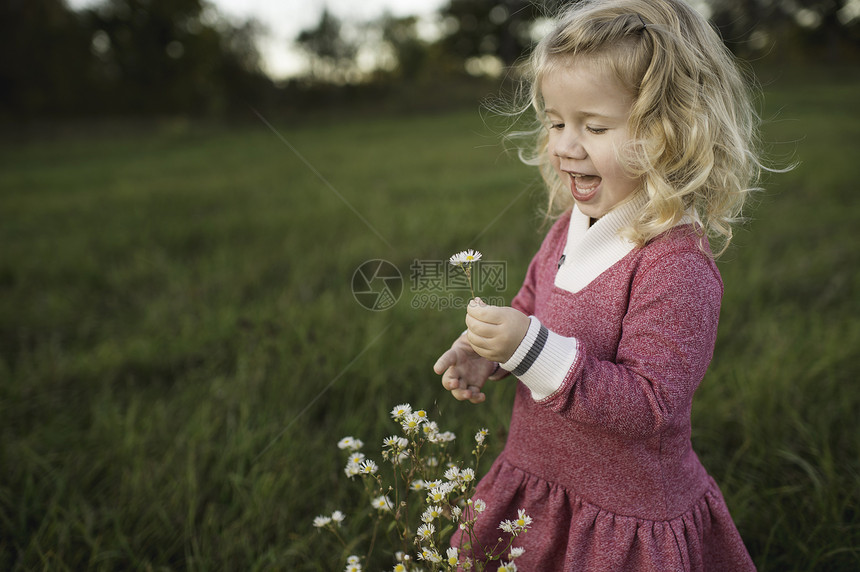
[434,0,759,572]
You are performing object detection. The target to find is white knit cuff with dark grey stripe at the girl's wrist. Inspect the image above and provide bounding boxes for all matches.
[501,316,579,401]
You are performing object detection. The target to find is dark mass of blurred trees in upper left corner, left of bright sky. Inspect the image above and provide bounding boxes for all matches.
[0,0,272,118]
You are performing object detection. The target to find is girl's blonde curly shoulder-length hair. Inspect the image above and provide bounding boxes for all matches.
[508,0,762,255]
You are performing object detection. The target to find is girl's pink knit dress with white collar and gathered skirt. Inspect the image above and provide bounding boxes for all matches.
[452,201,755,572]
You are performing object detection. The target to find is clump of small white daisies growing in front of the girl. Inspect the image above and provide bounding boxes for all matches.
[313,404,532,572]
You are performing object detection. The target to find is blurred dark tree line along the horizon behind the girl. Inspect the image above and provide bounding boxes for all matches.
[0,0,860,119]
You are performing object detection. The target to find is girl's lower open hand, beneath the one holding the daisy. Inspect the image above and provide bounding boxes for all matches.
[433,335,500,403]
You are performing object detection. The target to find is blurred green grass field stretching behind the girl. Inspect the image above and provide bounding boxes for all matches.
[0,66,860,571]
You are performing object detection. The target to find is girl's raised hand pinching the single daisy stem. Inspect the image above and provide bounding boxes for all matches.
[466,298,530,363]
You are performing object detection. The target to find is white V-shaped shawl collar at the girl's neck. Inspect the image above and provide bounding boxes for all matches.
[555,193,648,292]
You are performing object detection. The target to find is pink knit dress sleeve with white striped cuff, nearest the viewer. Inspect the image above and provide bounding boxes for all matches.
[503,251,722,437]
